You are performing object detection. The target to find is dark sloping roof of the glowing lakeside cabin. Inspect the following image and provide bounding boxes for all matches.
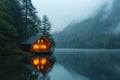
[22,34,42,44]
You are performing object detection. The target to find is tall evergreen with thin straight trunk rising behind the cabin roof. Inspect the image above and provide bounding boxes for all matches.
[21,0,41,37]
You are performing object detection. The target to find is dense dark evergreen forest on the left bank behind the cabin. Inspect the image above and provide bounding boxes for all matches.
[0,0,53,54]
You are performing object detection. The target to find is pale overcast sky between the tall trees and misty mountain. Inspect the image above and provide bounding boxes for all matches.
[32,0,111,33]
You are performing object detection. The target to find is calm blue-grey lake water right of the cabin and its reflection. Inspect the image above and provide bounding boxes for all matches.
[49,49,120,80]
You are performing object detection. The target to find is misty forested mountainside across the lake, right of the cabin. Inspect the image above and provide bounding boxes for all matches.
[54,0,120,48]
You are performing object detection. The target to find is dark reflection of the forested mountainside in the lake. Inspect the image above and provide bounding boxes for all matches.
[56,52,120,80]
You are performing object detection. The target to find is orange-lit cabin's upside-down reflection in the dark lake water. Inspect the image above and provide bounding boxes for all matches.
[23,56,56,80]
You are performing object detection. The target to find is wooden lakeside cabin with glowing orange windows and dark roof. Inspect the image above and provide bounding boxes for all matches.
[22,35,52,53]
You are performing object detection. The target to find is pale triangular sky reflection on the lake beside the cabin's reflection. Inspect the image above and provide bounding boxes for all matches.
[50,64,89,80]
